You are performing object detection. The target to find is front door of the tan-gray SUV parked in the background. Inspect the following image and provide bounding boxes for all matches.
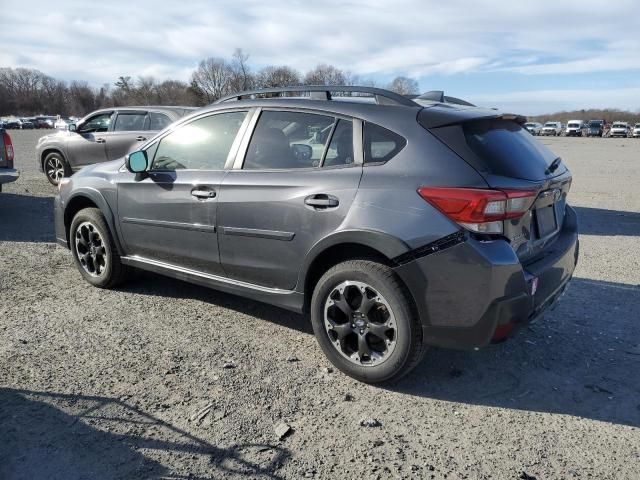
[67,112,113,169]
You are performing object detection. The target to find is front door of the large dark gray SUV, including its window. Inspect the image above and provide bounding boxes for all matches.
[118,111,247,274]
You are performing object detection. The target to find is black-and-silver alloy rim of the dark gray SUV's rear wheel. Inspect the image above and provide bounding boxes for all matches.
[324,281,397,366]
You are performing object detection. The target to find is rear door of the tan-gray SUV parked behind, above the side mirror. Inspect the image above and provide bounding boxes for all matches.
[106,110,149,160]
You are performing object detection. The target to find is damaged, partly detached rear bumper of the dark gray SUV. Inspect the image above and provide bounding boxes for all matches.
[396,207,578,349]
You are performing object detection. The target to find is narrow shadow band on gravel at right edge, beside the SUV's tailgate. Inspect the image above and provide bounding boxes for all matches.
[572,207,640,236]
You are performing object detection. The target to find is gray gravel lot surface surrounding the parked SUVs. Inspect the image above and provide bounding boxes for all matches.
[0,131,640,480]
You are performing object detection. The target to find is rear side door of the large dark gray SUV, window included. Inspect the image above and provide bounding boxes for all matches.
[218,109,362,289]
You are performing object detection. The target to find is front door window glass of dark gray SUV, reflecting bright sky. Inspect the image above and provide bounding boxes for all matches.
[151,112,247,170]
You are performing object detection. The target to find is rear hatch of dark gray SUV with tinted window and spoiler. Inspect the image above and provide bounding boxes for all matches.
[418,109,571,262]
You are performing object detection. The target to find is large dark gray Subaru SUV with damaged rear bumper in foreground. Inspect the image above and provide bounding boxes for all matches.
[55,86,578,382]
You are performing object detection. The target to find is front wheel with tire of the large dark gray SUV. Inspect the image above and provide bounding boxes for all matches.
[69,208,130,288]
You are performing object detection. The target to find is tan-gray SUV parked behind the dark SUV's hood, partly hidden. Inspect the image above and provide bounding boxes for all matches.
[36,107,194,185]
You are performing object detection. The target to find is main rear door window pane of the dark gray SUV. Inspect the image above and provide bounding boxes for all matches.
[243,111,335,170]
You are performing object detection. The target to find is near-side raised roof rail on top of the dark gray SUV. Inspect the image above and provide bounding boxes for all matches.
[214,85,420,107]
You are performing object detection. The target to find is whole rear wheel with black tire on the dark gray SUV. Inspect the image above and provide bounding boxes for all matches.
[311,260,424,383]
